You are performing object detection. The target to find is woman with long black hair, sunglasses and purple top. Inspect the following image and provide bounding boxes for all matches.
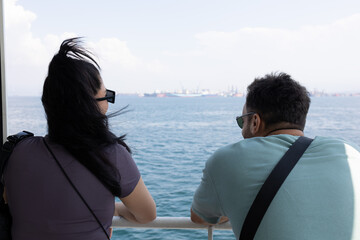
[4,38,156,240]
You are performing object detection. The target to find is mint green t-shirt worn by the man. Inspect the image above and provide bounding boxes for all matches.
[192,135,360,240]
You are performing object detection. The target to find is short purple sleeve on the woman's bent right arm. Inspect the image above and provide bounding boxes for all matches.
[107,144,140,198]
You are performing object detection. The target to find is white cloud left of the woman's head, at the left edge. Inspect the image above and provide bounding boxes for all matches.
[4,0,80,95]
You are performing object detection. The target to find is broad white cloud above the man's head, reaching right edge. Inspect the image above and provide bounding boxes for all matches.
[195,14,360,91]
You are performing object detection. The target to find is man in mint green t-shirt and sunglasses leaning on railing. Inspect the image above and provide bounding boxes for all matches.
[191,73,360,240]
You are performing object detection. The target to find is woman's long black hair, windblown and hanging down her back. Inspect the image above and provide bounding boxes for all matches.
[41,38,131,196]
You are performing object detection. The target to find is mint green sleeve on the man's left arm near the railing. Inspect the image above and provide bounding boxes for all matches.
[191,158,222,224]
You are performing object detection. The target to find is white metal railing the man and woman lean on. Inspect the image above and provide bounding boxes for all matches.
[112,217,231,240]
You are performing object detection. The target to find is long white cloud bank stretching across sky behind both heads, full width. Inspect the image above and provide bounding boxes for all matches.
[4,0,360,95]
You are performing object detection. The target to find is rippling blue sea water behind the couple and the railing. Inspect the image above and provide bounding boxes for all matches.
[7,97,360,240]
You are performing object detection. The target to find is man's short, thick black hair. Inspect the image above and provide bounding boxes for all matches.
[246,73,311,130]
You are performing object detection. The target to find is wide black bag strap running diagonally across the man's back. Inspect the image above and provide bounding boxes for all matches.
[239,136,313,240]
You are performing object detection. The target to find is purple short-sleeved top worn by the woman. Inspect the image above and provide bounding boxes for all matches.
[4,137,140,240]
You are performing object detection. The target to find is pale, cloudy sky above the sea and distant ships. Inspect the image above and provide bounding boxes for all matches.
[0,0,360,96]
